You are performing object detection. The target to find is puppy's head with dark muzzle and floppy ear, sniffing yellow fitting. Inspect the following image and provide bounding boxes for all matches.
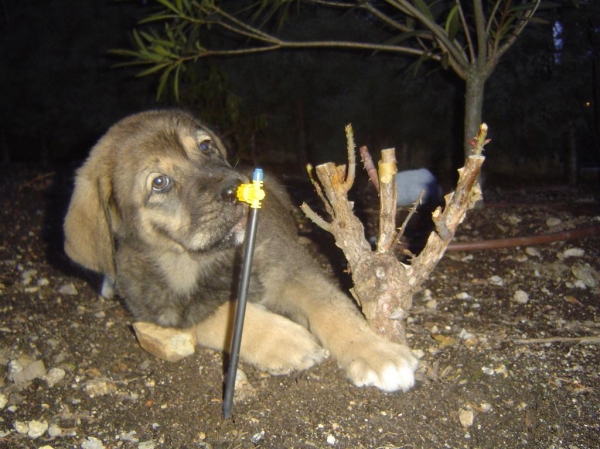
[65,111,247,275]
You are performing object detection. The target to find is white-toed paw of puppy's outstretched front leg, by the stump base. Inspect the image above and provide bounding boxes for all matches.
[345,336,419,391]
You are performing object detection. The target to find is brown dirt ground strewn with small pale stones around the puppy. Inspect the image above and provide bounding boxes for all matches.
[0,167,600,449]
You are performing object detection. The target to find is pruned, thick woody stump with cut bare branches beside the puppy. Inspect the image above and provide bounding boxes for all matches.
[302,124,488,342]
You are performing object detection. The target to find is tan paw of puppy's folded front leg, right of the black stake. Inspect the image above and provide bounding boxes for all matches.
[241,313,329,375]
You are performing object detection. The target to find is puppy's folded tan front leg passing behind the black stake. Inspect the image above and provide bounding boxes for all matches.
[193,302,327,374]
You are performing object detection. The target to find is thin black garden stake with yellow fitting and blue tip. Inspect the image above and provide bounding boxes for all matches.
[223,168,265,419]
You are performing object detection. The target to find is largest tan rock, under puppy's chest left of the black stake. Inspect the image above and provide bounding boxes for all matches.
[133,322,196,362]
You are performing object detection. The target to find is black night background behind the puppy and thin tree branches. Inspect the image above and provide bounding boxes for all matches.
[0,0,600,182]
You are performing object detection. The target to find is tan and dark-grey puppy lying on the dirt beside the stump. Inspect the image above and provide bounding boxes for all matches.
[64,110,417,391]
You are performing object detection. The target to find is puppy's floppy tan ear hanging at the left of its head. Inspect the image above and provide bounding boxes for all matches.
[64,142,118,279]
